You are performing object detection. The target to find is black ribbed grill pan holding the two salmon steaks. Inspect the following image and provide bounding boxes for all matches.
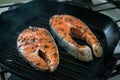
[0,0,119,80]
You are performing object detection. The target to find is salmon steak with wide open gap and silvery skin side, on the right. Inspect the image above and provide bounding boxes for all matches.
[49,14,103,61]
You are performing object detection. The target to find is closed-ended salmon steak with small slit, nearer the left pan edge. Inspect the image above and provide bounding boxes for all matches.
[17,27,59,72]
